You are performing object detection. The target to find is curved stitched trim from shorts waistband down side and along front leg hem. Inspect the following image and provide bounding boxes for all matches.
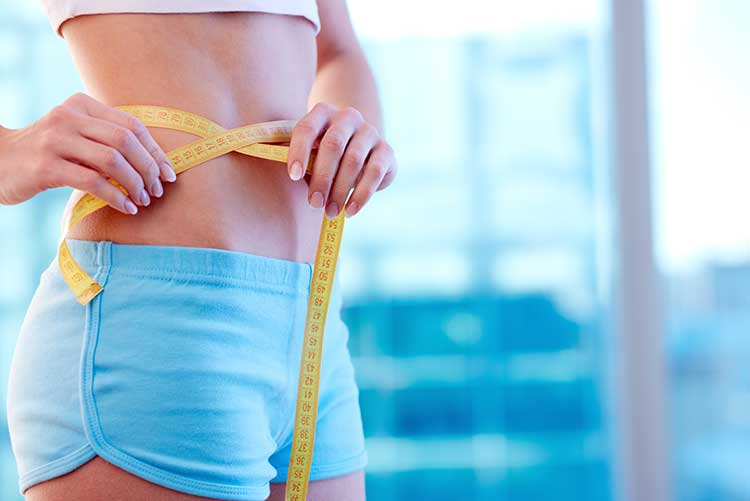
[79,248,270,499]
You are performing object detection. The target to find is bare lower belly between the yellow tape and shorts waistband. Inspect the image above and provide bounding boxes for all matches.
[66,153,323,262]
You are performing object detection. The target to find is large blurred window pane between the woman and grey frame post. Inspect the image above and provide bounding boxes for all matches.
[340,0,610,500]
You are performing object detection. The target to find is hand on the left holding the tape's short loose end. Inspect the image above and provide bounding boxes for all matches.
[0,93,177,214]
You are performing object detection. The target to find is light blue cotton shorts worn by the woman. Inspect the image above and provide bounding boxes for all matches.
[7,239,367,500]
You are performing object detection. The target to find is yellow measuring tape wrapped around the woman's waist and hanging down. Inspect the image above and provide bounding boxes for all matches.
[58,105,344,501]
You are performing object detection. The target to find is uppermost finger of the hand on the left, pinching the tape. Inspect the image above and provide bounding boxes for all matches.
[72,93,177,182]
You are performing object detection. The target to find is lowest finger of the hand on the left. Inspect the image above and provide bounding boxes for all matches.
[52,159,138,215]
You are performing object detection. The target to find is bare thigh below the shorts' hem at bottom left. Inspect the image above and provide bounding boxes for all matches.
[26,456,225,501]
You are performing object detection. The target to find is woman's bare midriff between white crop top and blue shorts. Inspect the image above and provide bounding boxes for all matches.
[62,12,323,262]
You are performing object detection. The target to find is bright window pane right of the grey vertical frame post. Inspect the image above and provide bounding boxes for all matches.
[651,0,750,501]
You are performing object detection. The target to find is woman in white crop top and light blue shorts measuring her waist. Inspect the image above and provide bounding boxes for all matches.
[0,0,396,501]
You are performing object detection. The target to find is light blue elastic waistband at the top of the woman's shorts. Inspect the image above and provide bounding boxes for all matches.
[65,238,313,292]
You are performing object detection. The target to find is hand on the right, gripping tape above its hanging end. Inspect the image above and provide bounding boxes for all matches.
[287,102,396,218]
